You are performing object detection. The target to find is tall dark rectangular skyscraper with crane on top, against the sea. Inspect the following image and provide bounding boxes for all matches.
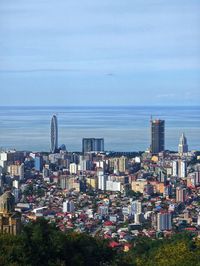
[151,119,165,154]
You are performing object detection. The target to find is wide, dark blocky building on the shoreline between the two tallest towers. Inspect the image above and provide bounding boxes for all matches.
[82,138,104,153]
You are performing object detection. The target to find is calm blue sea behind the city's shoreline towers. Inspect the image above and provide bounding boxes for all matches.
[0,107,200,151]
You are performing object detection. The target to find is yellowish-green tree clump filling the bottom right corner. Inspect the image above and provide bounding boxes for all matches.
[117,233,200,266]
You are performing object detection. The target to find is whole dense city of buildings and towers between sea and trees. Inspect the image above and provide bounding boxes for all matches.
[0,115,200,262]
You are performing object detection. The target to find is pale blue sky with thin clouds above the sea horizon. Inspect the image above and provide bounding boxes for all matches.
[0,0,200,106]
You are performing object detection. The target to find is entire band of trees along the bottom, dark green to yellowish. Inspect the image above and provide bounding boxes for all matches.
[0,220,200,266]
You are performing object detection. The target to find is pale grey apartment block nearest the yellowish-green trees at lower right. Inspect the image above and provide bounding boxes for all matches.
[157,212,172,231]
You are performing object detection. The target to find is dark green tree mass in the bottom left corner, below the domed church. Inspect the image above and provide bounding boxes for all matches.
[0,219,114,266]
